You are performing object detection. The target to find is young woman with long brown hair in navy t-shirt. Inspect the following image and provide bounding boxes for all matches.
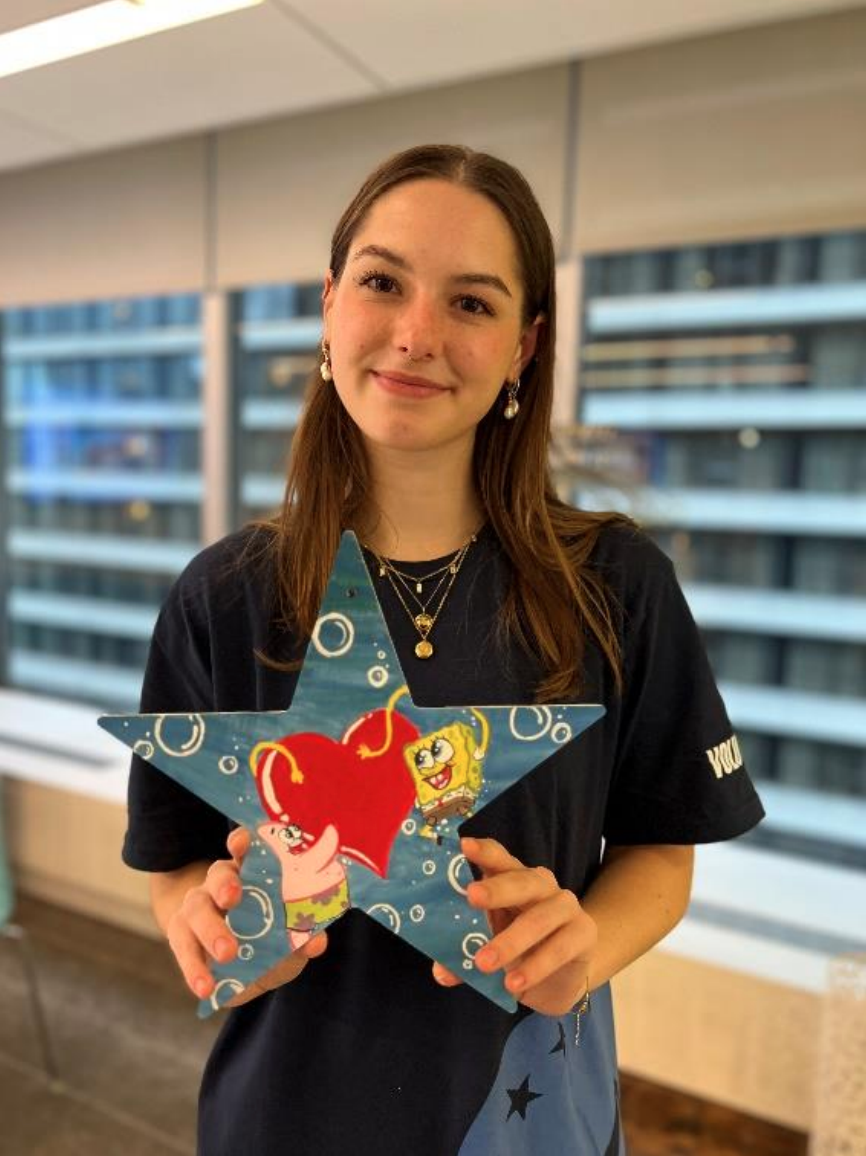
[125,146,763,1156]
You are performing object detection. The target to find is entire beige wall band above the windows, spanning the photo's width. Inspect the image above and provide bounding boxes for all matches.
[0,9,866,306]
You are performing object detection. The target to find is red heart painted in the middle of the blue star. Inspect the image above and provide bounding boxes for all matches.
[253,710,420,877]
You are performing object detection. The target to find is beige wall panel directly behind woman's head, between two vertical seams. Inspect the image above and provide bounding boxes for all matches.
[215,65,569,288]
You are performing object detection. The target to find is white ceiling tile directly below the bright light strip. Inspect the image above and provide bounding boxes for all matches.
[0,5,376,164]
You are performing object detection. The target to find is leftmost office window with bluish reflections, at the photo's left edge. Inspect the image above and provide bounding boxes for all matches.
[1,296,202,709]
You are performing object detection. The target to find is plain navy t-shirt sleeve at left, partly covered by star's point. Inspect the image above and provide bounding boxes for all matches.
[123,572,230,872]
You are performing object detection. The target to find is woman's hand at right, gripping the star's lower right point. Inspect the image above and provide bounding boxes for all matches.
[434,839,598,1015]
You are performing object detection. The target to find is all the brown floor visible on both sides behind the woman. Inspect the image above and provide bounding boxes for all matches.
[0,899,807,1156]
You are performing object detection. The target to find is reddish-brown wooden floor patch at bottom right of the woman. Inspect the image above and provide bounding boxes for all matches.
[621,1075,808,1156]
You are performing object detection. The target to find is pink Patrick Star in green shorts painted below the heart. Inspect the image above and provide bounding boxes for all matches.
[258,823,349,950]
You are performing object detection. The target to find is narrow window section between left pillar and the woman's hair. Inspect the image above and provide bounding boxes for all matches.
[235,283,321,525]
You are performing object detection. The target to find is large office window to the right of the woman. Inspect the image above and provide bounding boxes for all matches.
[577,232,866,864]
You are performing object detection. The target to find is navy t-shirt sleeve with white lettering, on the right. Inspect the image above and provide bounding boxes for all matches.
[605,543,764,844]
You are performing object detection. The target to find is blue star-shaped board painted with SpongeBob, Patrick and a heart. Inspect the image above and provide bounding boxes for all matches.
[99,534,605,1015]
